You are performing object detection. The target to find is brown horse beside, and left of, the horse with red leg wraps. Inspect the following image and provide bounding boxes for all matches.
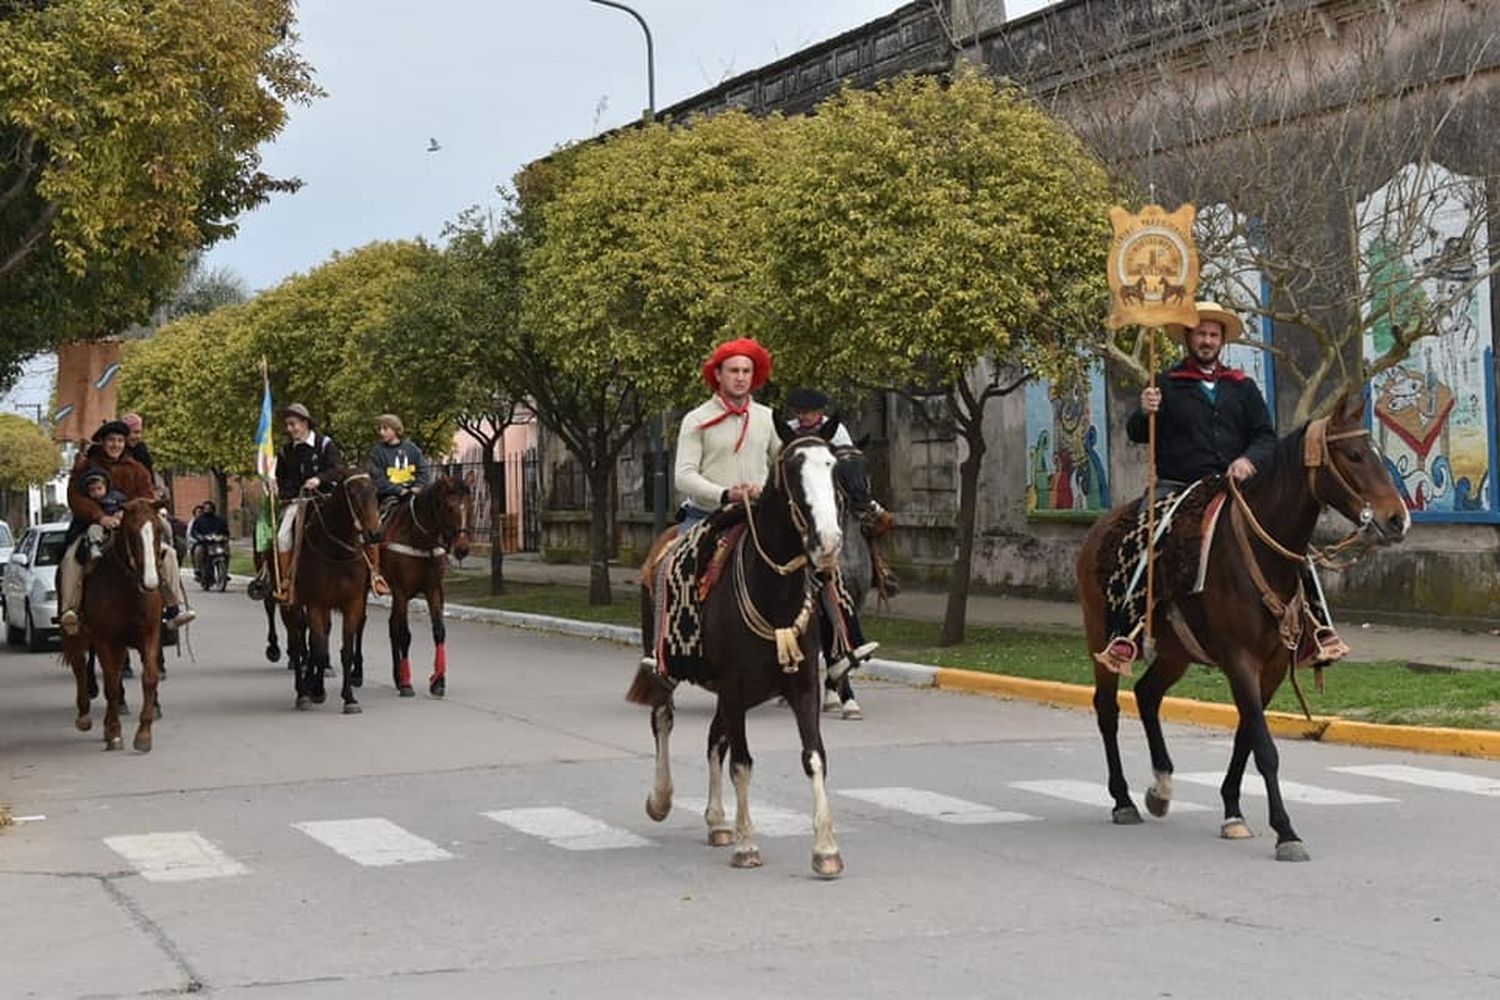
[282,472,380,715]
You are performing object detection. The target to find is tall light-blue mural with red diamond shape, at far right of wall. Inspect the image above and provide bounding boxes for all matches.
[1359,165,1500,520]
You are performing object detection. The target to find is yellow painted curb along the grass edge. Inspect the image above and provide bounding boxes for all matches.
[933,667,1500,760]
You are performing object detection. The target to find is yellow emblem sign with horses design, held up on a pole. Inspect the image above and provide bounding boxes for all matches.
[1109,205,1199,330]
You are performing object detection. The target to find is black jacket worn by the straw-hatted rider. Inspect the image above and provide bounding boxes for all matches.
[1125,361,1277,483]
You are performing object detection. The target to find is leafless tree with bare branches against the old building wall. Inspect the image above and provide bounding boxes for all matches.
[1053,0,1500,423]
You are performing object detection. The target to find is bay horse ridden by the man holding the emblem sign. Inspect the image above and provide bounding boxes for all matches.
[1077,394,1412,861]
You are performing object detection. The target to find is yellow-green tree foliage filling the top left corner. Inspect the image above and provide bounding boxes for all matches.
[0,0,320,384]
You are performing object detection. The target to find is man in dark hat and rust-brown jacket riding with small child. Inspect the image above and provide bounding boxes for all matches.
[57,420,195,636]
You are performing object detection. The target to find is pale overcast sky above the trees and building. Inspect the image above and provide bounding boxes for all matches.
[207,0,1047,289]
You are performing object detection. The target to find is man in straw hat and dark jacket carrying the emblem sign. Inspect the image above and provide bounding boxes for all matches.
[1095,301,1349,673]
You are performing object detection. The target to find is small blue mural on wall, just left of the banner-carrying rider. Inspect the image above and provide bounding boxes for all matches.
[1026,364,1110,514]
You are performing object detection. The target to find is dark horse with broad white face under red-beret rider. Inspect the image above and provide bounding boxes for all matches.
[626,421,843,879]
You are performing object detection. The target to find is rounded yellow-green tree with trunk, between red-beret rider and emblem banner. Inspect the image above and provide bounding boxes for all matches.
[765,67,1112,645]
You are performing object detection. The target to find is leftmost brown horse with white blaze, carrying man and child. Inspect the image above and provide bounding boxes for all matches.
[63,499,162,753]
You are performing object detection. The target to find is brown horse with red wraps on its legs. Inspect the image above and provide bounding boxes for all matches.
[381,475,470,699]
